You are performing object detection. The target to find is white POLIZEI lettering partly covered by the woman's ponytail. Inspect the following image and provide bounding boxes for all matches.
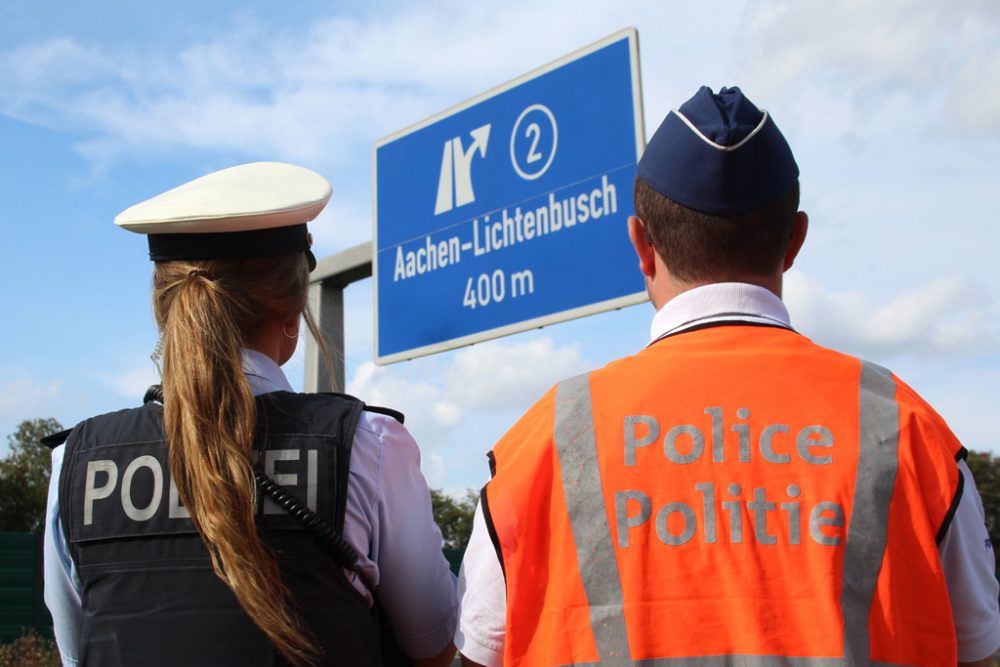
[81,449,319,526]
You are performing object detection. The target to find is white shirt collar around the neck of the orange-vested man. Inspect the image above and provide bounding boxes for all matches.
[649,283,791,341]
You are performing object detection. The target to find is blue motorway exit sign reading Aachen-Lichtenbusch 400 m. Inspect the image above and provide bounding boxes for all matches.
[373,29,646,363]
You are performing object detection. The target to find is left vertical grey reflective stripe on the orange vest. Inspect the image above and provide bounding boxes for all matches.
[554,375,630,664]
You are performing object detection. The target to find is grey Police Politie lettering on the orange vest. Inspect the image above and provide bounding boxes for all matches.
[614,406,844,548]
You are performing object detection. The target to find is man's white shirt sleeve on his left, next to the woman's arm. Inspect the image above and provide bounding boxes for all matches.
[455,503,507,667]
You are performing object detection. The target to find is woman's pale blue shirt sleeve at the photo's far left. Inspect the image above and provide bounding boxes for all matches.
[42,445,83,665]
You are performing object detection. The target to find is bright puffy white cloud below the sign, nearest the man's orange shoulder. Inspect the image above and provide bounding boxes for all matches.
[445,337,589,408]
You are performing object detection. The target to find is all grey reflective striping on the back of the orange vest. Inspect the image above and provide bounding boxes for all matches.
[555,362,899,667]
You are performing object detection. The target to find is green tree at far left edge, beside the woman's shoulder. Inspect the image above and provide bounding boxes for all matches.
[0,417,62,533]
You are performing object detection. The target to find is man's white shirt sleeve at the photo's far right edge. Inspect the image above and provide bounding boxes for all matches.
[938,461,1000,662]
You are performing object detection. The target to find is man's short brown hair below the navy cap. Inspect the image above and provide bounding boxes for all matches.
[634,176,799,282]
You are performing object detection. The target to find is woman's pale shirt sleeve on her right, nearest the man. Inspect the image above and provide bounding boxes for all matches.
[344,412,458,658]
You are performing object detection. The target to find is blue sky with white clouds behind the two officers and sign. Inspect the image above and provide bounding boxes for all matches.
[0,0,1000,489]
